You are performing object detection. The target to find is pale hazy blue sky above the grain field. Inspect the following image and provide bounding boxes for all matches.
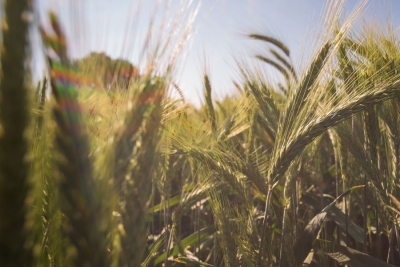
[37,0,400,106]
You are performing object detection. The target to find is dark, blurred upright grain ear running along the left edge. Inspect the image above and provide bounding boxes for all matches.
[0,0,31,266]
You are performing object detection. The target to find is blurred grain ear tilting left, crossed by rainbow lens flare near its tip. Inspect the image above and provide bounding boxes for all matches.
[43,13,109,266]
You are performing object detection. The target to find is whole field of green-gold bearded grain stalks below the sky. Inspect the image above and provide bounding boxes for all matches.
[0,1,400,267]
